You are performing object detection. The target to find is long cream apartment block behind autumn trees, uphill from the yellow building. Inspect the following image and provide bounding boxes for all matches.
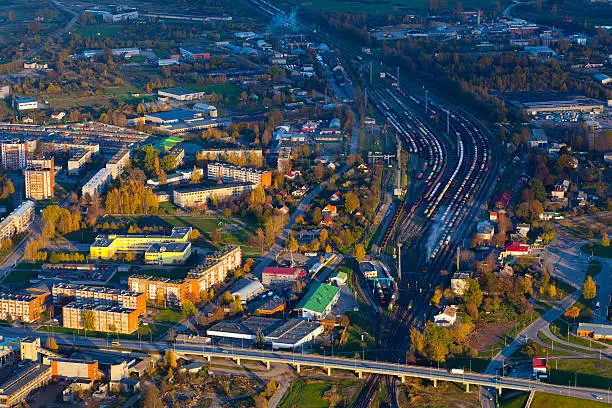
[172,183,254,208]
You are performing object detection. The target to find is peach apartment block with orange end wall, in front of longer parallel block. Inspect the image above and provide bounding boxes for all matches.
[62,302,138,334]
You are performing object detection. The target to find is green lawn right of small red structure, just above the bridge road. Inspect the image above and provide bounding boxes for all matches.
[548,359,612,390]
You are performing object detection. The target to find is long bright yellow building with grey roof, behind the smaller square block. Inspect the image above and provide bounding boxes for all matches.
[89,227,191,259]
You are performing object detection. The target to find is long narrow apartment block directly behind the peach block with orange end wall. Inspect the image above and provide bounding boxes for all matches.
[51,283,147,315]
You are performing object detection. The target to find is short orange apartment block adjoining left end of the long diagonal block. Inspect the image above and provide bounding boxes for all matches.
[128,275,189,306]
